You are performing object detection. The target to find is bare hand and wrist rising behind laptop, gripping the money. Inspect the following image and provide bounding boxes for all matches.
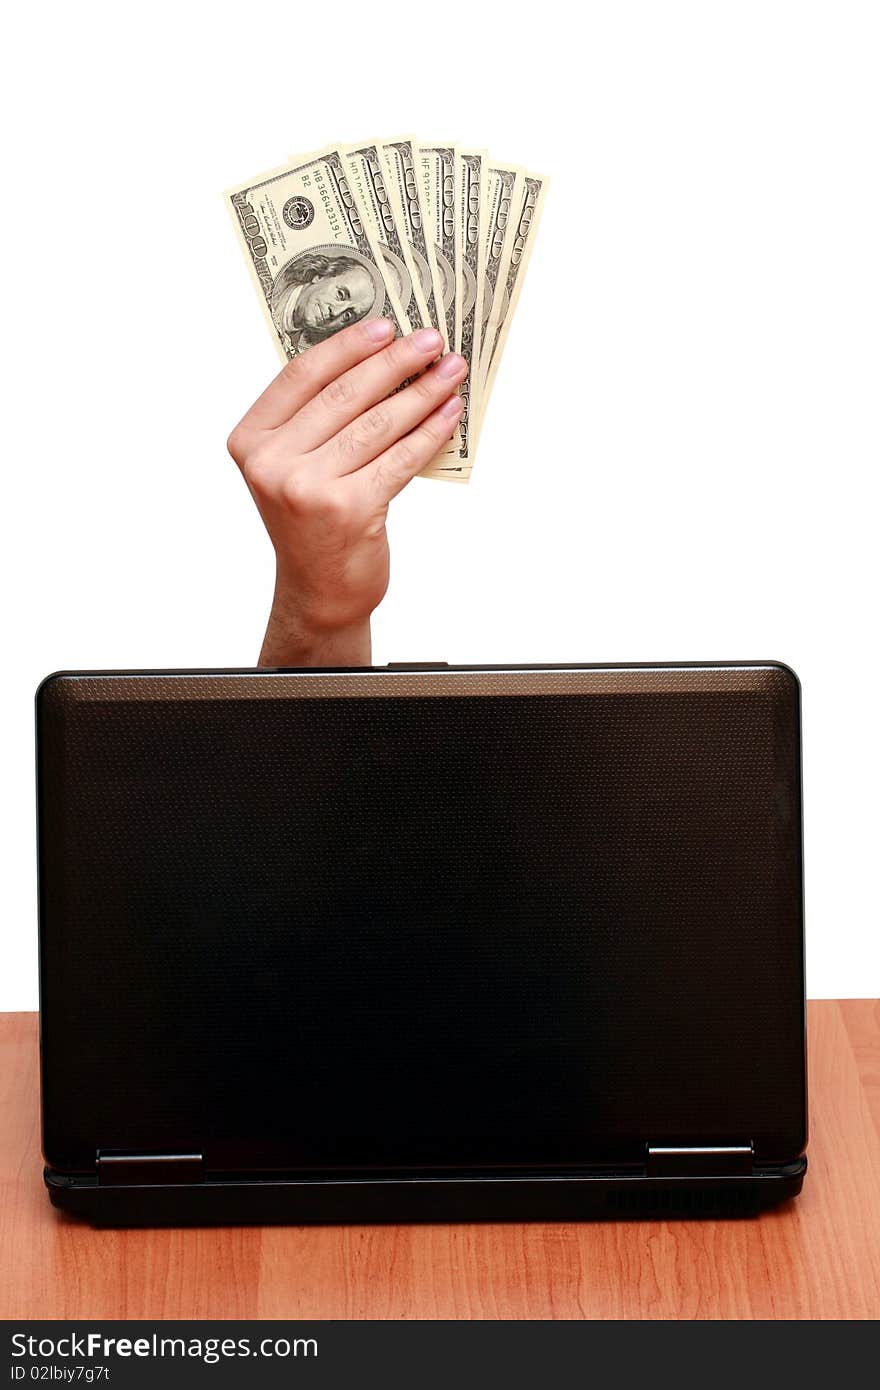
[228,318,467,666]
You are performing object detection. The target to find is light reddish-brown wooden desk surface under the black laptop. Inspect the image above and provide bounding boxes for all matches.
[0,999,880,1319]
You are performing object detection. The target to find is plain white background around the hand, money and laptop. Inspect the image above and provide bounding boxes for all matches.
[0,0,880,1009]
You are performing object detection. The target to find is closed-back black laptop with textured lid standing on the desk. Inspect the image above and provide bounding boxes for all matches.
[36,662,806,1225]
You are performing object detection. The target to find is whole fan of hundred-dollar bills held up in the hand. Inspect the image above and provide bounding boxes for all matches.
[225,138,546,482]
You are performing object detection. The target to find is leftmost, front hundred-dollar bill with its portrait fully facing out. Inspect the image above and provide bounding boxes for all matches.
[225,149,406,360]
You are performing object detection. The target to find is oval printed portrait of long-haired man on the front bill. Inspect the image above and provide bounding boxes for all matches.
[268,246,385,356]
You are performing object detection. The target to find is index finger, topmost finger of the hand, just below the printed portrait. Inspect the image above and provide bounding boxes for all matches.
[236,318,395,430]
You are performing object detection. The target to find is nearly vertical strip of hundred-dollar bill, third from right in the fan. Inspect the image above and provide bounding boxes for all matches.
[455,150,488,460]
